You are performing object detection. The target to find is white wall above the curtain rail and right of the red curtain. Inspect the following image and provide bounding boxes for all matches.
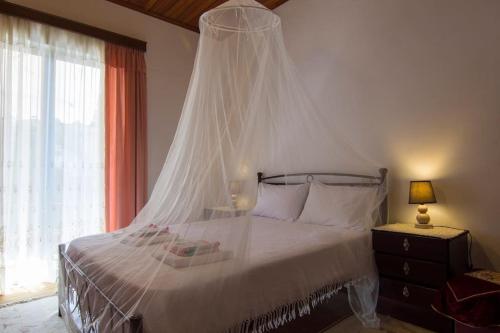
[5,0,198,192]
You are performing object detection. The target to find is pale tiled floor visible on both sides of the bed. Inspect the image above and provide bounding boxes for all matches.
[0,296,429,333]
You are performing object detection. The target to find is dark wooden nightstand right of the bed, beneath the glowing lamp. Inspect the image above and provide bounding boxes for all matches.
[372,223,468,332]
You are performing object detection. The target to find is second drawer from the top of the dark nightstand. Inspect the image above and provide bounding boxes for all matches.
[375,253,447,288]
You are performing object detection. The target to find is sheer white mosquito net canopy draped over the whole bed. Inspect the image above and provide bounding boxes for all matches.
[59,0,386,333]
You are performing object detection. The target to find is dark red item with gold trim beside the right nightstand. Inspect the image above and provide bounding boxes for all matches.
[432,271,500,327]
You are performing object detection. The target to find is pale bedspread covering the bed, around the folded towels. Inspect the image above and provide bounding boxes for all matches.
[67,217,373,333]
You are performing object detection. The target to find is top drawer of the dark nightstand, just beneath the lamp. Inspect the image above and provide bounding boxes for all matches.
[373,230,448,262]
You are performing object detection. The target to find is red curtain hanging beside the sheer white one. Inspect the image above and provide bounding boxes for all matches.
[105,43,147,231]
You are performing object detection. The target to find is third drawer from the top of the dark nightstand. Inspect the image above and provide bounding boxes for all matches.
[380,278,439,309]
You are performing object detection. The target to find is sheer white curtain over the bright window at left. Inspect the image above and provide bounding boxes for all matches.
[0,15,104,293]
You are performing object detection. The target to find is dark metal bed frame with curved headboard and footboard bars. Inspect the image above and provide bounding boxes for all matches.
[58,168,388,333]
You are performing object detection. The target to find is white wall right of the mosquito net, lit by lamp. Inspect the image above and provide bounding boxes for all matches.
[276,0,500,269]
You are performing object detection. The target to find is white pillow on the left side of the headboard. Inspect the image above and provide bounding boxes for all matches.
[252,183,309,221]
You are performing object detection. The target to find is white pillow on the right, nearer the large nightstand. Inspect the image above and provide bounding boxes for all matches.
[299,183,378,226]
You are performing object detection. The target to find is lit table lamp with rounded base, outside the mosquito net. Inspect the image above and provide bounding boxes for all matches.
[408,180,437,229]
